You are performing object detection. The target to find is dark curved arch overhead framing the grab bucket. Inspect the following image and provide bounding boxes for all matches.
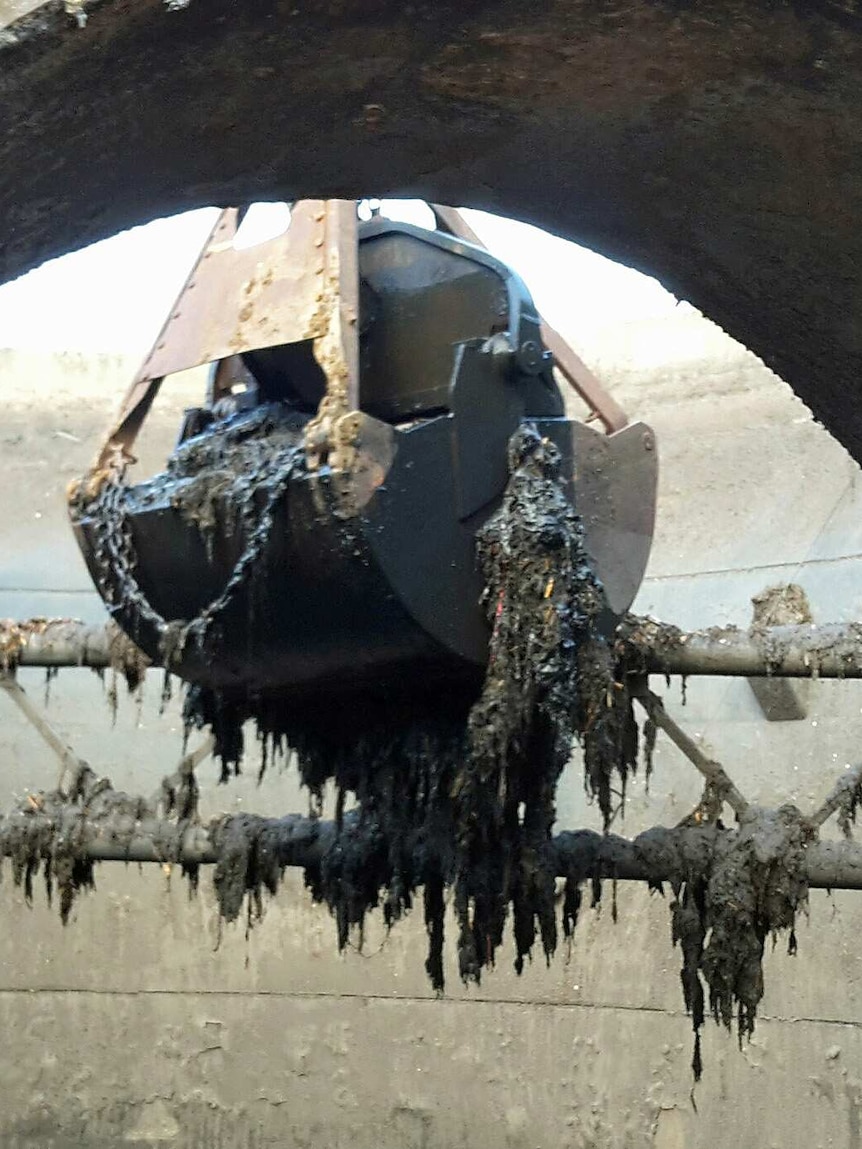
[0,0,862,460]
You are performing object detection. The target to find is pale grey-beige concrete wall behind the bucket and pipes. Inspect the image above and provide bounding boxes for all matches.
[0,326,862,1149]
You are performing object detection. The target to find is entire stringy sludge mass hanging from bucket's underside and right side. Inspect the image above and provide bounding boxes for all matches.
[186,427,637,989]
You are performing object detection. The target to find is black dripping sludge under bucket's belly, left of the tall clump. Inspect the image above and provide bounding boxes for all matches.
[236,684,469,990]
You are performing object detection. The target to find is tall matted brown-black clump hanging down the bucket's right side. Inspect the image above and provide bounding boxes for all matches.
[453,426,637,979]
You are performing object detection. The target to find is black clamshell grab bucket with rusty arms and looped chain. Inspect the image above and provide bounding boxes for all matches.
[71,201,657,694]
